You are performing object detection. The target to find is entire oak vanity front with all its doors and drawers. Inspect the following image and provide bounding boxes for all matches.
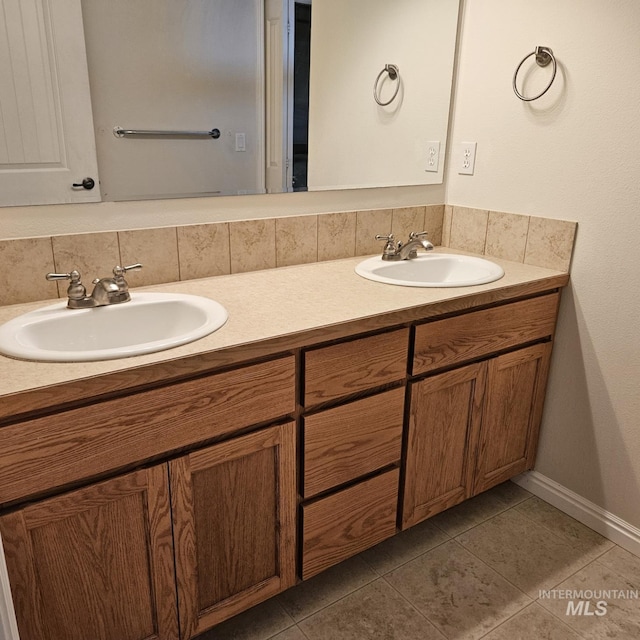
[0,290,559,640]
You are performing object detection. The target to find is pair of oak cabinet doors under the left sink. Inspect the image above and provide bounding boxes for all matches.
[0,422,296,640]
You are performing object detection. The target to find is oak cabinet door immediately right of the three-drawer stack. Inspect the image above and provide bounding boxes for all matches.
[402,364,486,529]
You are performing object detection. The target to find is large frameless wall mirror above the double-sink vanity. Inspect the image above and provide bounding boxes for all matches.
[0,0,459,205]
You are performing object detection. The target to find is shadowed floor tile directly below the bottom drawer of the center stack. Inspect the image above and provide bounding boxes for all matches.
[278,556,378,622]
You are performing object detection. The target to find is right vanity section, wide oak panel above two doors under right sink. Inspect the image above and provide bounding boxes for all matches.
[402,293,559,529]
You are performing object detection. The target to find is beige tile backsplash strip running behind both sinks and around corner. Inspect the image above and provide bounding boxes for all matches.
[0,205,576,305]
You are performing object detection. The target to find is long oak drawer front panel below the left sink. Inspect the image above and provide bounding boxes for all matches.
[0,356,295,504]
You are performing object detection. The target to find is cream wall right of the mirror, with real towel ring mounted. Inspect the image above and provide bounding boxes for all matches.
[446,0,640,527]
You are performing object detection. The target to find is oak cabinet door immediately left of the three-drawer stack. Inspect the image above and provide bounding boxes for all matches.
[169,422,297,638]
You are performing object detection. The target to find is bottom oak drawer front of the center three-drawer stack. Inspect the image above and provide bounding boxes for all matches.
[302,469,400,580]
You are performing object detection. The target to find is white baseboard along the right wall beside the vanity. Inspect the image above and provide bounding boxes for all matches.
[513,471,640,556]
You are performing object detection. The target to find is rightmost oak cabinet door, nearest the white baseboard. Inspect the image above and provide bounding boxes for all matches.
[474,342,551,494]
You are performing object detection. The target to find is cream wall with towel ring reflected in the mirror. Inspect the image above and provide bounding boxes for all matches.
[308,0,458,189]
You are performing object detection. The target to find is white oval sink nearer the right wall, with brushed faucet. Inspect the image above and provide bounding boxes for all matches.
[356,253,504,287]
